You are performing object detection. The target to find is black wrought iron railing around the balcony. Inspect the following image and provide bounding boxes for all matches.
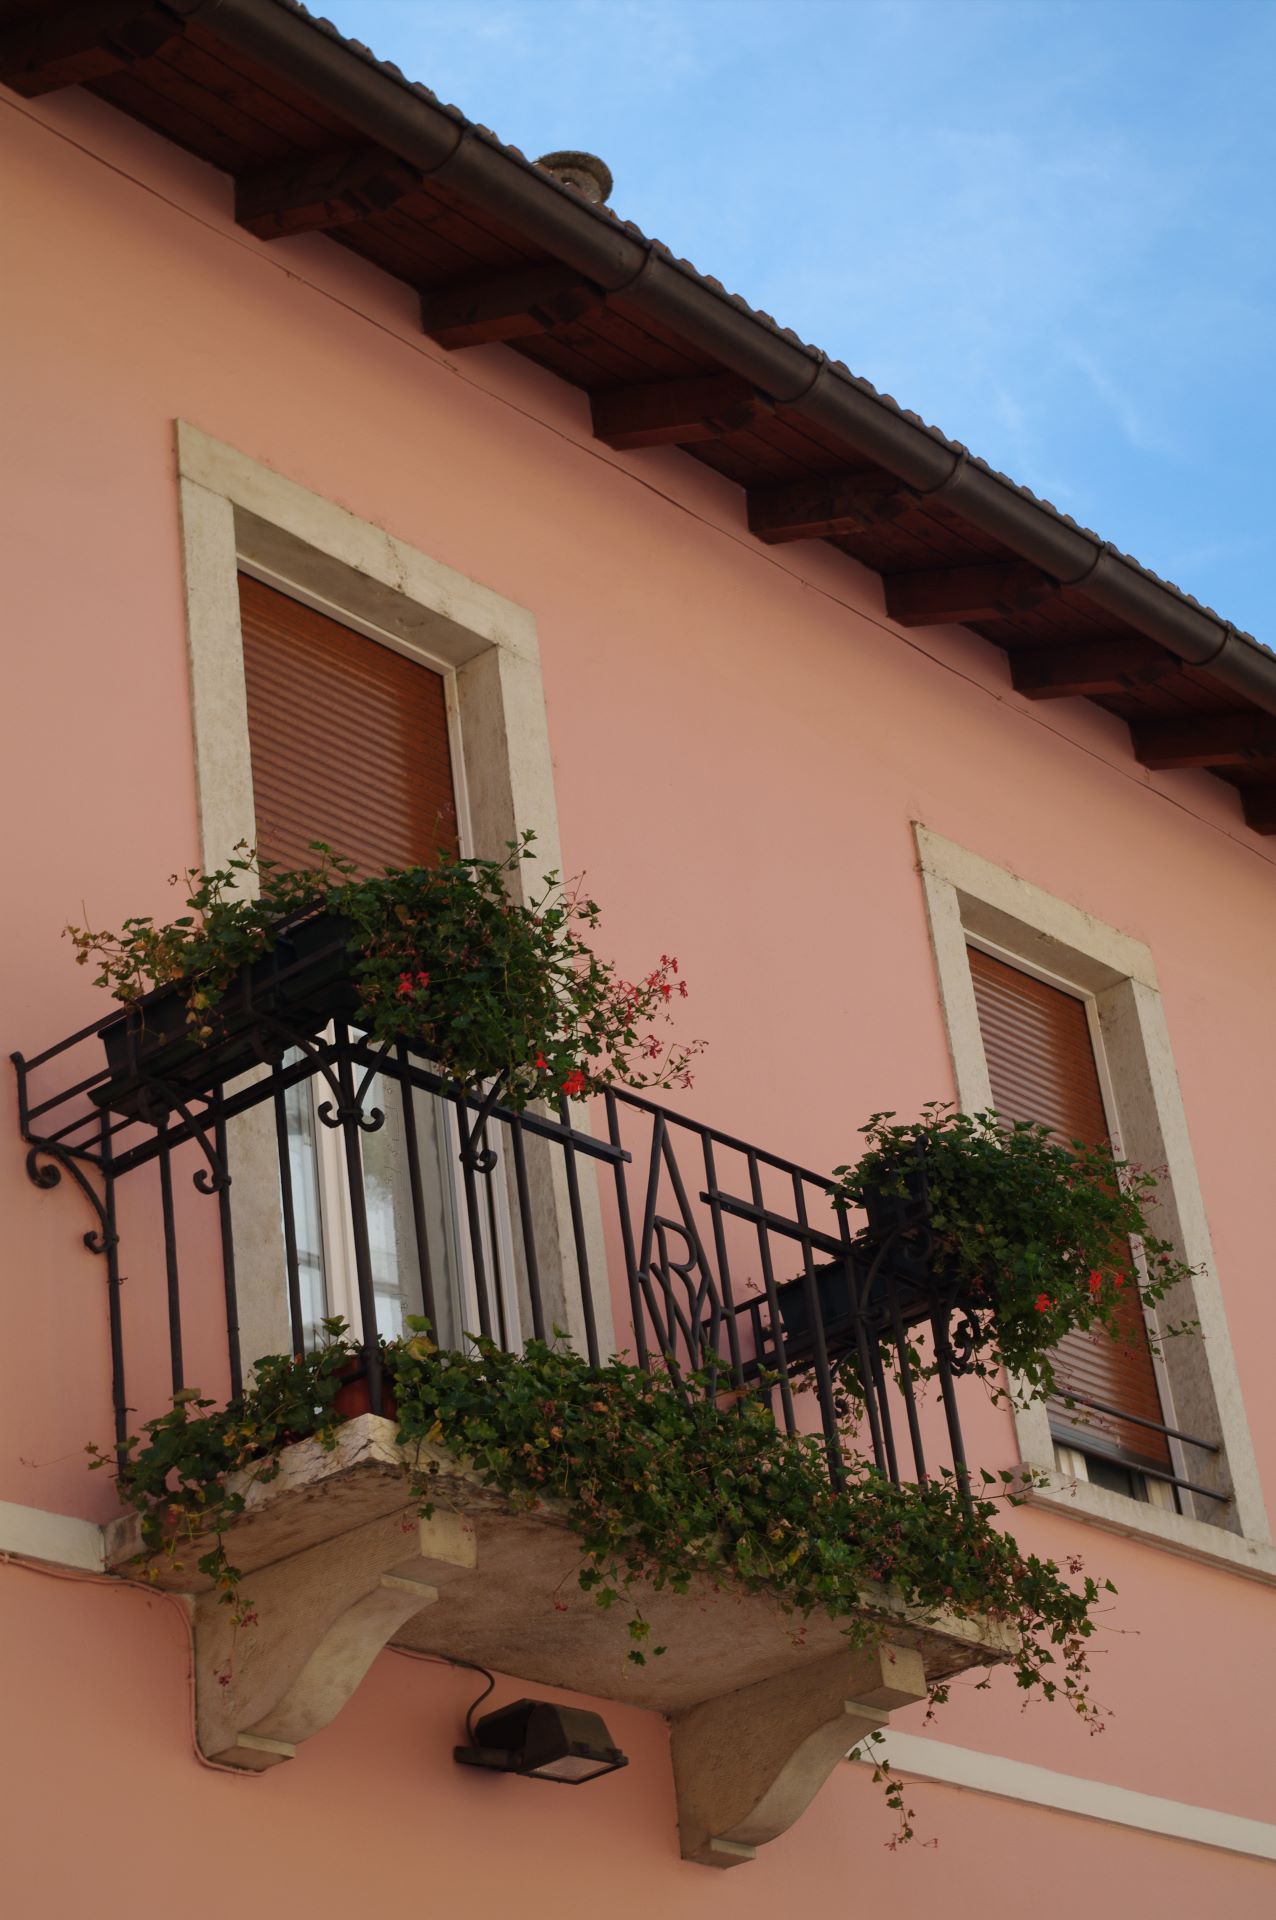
[13,956,977,1482]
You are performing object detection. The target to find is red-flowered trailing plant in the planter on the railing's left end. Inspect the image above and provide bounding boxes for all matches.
[67,831,702,1108]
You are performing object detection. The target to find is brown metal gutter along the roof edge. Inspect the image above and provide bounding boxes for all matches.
[187,0,1276,714]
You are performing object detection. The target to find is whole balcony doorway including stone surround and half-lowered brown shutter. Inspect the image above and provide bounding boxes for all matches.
[177,422,614,1359]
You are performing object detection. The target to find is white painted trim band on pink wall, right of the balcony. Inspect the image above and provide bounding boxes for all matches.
[850,1734,1276,1860]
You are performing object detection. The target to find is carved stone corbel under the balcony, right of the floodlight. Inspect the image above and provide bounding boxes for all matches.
[673,1642,927,1866]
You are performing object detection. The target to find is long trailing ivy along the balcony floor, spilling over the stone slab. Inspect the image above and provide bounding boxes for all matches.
[90,1321,1115,1837]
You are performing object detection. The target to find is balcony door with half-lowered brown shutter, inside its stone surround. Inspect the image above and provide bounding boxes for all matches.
[238,572,516,1344]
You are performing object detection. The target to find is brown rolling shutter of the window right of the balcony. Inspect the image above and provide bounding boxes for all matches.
[967,947,1170,1467]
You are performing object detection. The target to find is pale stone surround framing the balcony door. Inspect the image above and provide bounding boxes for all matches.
[175,420,614,1356]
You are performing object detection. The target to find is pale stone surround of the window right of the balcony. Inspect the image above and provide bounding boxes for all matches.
[913,822,1276,1582]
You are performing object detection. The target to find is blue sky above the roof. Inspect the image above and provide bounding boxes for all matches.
[324,0,1276,645]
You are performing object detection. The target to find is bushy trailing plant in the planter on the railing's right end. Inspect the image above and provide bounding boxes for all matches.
[835,1102,1195,1400]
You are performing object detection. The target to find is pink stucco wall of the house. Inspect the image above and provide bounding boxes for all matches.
[0,82,1276,1920]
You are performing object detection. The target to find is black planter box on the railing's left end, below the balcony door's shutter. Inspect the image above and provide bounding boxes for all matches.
[92,914,359,1117]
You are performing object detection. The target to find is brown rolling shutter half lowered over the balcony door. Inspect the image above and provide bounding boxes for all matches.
[240,574,457,872]
